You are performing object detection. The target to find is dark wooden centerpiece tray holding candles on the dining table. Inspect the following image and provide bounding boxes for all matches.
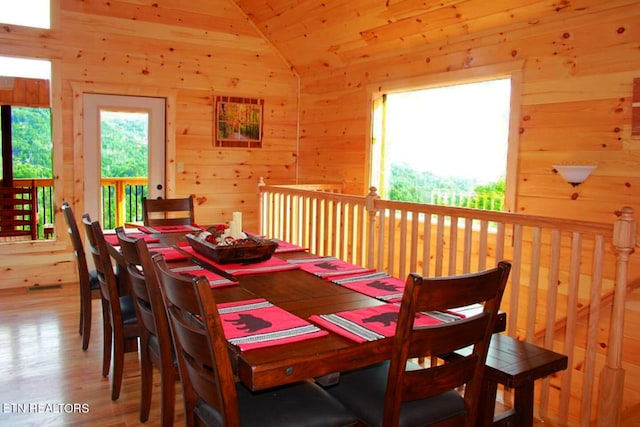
[185,234,278,264]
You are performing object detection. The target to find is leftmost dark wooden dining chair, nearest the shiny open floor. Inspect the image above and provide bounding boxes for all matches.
[62,201,100,350]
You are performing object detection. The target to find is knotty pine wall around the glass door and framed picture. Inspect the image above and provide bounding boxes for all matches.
[0,0,299,289]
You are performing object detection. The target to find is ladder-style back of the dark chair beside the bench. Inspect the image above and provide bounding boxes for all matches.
[383,261,511,426]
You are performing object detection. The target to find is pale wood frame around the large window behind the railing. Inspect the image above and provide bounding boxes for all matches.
[365,61,524,212]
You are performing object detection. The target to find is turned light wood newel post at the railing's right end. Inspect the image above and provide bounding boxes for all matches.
[598,207,636,426]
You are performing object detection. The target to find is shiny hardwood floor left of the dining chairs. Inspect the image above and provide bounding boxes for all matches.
[0,285,184,426]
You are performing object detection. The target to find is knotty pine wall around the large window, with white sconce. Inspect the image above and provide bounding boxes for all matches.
[292,1,640,280]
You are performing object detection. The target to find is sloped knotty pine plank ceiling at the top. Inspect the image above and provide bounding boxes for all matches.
[234,0,617,74]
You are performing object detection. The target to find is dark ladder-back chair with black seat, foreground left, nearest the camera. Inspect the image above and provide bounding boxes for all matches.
[153,255,356,427]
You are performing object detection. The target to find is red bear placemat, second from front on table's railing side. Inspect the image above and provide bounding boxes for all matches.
[331,271,405,302]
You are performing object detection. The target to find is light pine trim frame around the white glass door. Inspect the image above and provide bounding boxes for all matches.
[70,82,177,224]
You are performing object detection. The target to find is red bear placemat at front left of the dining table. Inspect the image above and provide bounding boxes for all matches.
[218,298,328,351]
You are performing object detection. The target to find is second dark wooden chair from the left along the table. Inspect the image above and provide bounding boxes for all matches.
[82,214,140,400]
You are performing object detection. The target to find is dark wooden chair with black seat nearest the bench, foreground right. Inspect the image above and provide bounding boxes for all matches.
[327,261,511,427]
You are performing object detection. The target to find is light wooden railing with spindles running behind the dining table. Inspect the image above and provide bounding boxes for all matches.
[259,182,635,425]
